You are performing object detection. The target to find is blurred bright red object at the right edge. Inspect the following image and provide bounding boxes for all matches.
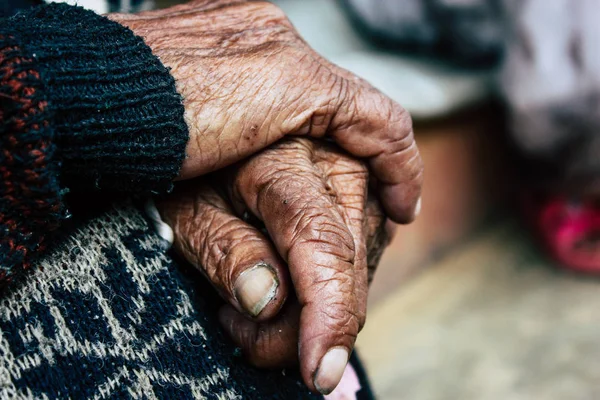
[525,196,600,274]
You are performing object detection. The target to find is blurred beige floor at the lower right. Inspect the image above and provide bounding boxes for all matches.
[358,222,600,400]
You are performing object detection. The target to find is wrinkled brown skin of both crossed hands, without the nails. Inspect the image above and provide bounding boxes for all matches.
[109,0,423,390]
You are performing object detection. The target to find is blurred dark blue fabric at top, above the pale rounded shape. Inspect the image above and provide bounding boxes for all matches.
[338,0,504,69]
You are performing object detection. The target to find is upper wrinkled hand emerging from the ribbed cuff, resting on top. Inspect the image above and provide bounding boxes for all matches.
[109,0,423,223]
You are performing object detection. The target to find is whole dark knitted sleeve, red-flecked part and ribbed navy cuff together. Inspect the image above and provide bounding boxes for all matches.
[0,4,188,285]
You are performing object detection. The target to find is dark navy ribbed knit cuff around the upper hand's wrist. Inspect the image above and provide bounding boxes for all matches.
[10,4,188,193]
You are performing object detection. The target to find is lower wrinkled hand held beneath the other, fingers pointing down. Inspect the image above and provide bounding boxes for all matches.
[158,138,388,393]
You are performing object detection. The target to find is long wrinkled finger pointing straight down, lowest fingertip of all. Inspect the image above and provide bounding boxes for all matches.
[235,141,364,393]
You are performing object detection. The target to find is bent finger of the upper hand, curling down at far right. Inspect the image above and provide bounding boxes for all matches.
[331,86,423,223]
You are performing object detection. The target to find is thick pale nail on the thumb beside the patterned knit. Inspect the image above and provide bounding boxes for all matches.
[234,263,278,317]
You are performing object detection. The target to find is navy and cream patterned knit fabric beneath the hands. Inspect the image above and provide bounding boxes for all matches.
[0,204,321,400]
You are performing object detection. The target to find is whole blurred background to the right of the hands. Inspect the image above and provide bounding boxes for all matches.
[268,0,600,400]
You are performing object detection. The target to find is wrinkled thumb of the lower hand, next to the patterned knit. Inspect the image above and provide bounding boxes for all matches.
[159,182,289,320]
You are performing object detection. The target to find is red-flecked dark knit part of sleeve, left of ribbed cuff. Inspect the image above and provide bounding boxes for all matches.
[0,32,65,286]
